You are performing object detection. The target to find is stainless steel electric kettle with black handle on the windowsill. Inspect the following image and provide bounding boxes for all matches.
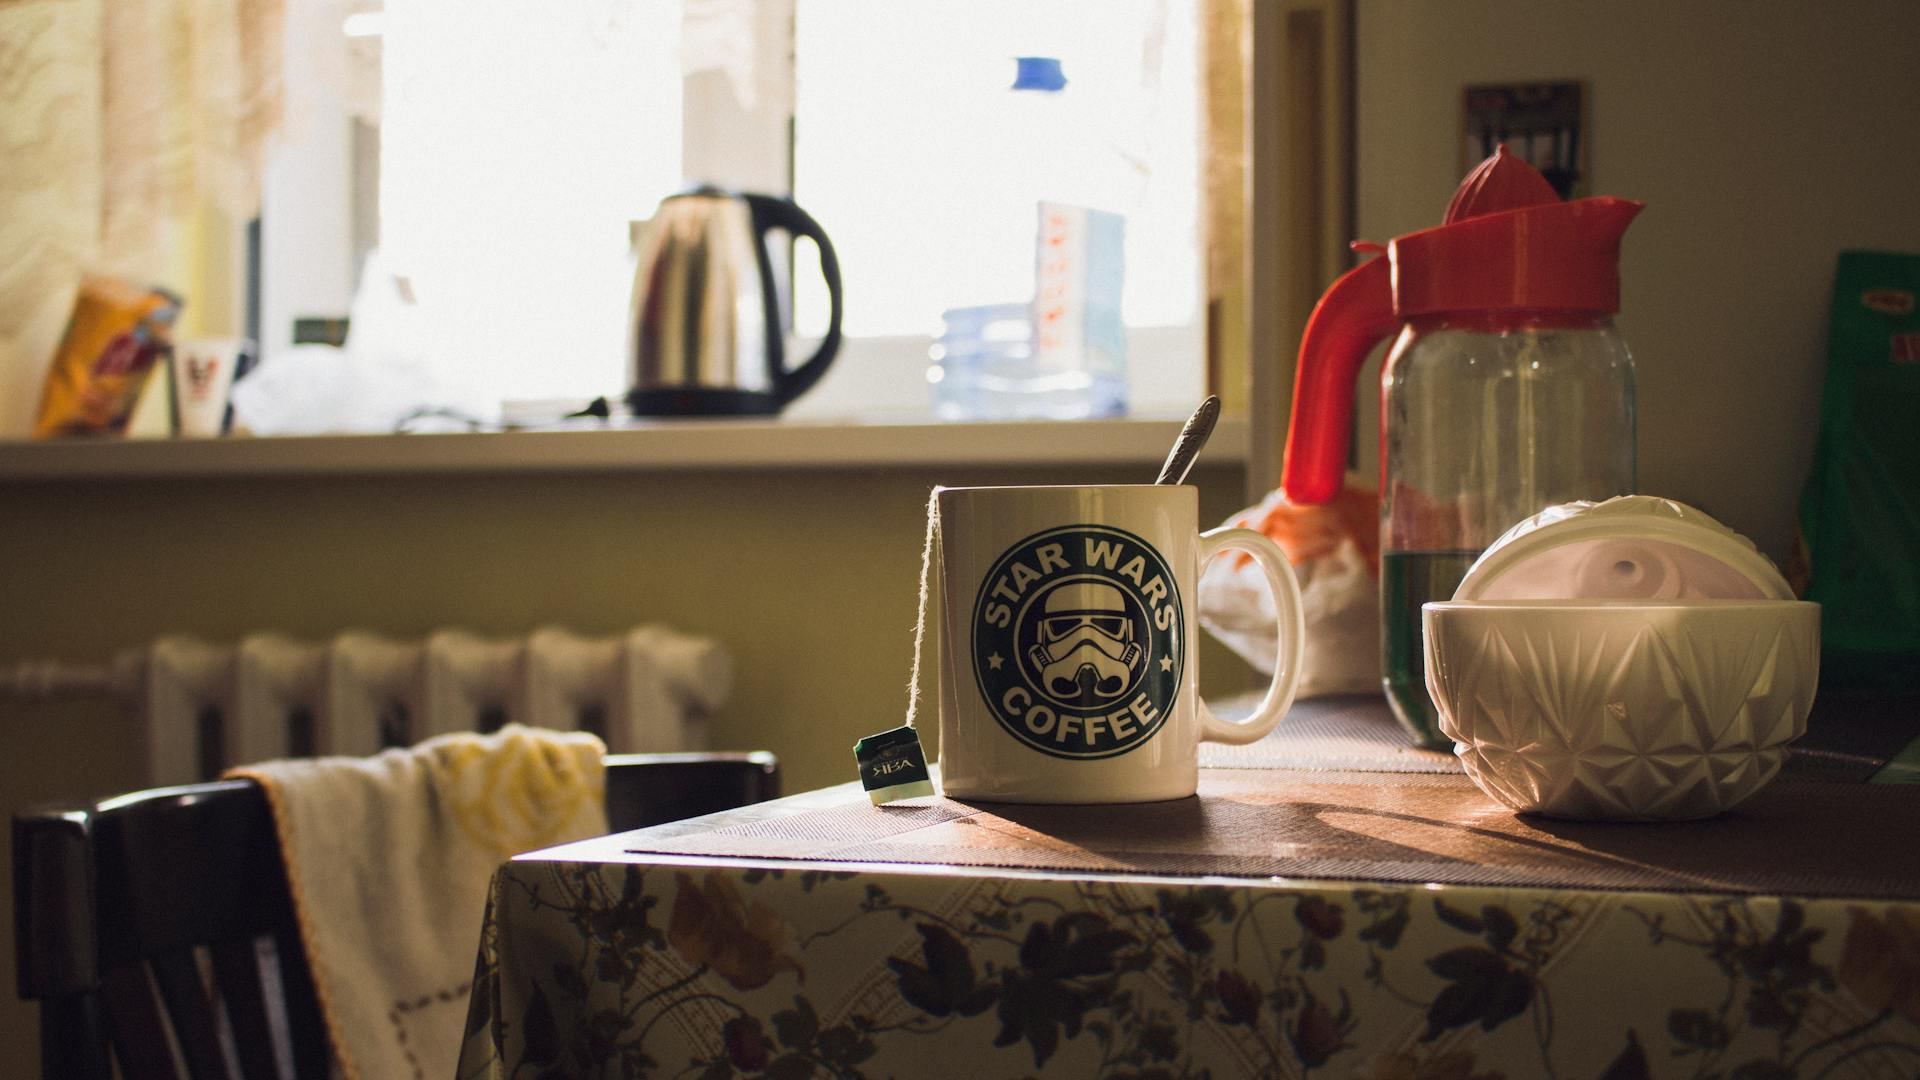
[626,186,841,417]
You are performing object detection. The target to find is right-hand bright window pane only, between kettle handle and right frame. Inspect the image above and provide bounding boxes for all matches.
[793,0,1202,413]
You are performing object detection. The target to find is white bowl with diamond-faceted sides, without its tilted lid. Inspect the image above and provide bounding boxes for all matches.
[1425,600,1820,821]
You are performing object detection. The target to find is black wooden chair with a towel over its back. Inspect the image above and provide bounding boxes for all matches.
[13,751,780,1080]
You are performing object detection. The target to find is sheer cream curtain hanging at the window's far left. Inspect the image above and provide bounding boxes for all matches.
[0,0,282,436]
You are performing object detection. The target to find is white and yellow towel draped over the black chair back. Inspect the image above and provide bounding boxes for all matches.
[228,724,607,1080]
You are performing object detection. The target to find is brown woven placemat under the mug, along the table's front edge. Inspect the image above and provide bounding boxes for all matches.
[622,769,1920,899]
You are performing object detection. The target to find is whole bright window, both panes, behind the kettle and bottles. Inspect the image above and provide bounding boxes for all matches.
[263,0,1204,426]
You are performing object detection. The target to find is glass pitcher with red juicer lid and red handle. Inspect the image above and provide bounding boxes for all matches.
[1281,148,1644,746]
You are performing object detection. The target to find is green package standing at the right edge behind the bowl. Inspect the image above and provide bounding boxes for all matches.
[1799,252,1920,692]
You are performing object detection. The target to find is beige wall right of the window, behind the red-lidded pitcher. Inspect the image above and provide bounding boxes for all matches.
[1356,0,1920,555]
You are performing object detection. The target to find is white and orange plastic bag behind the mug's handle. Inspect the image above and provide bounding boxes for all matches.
[1200,486,1380,698]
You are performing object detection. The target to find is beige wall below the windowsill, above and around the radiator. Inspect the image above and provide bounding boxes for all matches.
[0,455,1248,1076]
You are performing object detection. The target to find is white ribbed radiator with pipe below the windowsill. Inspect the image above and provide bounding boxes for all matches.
[0,626,733,786]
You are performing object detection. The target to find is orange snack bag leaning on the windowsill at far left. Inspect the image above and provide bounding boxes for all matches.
[33,275,180,438]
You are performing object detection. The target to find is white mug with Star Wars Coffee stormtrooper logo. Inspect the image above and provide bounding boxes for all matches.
[937,484,1304,803]
